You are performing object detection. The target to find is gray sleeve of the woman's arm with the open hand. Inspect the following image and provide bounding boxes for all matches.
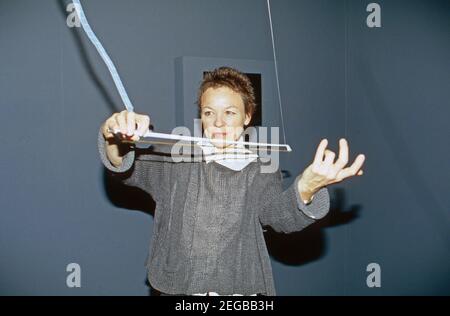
[259,170,330,233]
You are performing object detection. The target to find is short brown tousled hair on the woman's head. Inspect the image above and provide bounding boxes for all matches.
[197,67,256,117]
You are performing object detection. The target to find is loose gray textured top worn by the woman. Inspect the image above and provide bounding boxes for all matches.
[98,127,330,295]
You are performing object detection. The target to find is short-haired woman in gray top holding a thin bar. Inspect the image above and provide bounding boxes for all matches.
[98,67,364,295]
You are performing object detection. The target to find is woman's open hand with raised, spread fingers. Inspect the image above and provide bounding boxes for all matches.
[298,138,365,201]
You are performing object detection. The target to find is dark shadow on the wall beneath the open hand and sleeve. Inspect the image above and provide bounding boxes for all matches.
[264,188,361,266]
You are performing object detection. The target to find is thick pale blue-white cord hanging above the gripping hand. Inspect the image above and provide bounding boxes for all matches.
[72,0,134,112]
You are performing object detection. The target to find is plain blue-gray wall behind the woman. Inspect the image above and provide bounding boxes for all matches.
[0,0,450,295]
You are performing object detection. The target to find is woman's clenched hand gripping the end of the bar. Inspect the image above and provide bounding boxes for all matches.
[102,110,150,141]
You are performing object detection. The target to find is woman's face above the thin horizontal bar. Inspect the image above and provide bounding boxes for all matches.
[201,86,251,148]
